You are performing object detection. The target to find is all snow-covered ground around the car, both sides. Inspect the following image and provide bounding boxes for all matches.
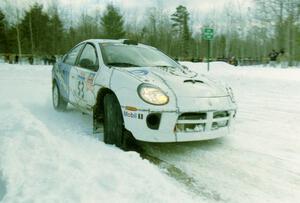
[0,62,300,203]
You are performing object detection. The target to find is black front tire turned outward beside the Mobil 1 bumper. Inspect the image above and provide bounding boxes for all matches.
[103,94,134,151]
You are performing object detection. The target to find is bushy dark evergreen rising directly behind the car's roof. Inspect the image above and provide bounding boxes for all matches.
[101,4,125,39]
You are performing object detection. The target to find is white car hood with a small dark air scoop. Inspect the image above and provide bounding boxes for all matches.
[118,67,228,98]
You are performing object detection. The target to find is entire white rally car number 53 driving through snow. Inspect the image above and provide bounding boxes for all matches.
[52,39,236,148]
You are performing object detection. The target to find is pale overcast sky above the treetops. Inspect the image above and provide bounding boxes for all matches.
[0,0,253,26]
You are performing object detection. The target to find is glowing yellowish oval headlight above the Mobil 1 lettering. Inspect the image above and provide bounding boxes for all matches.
[138,84,169,105]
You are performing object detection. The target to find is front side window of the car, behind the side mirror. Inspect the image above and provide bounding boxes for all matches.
[78,44,99,71]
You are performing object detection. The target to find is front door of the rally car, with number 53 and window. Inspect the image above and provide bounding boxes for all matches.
[75,43,99,109]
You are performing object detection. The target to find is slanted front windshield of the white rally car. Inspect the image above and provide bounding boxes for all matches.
[100,43,181,68]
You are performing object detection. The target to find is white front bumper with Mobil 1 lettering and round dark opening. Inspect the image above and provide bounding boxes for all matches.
[122,104,236,142]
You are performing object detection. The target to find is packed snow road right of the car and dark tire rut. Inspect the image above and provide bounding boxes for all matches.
[141,63,300,202]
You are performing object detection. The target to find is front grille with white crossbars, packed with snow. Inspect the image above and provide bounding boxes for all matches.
[175,111,230,132]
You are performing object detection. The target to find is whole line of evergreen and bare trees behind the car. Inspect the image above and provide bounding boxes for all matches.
[0,0,300,65]
